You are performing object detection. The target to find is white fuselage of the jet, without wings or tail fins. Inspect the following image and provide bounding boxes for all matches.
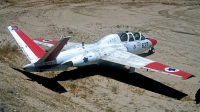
[23,33,152,72]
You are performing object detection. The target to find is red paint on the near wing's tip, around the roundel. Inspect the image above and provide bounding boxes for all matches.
[145,62,194,80]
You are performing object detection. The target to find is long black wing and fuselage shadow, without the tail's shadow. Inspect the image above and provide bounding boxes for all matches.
[54,64,187,100]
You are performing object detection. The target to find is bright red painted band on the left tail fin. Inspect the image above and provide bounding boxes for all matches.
[11,26,46,58]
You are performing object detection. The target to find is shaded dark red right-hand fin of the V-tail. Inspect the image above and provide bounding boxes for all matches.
[36,37,70,63]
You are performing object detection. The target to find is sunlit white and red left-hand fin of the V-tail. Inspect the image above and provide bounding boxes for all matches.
[8,26,46,63]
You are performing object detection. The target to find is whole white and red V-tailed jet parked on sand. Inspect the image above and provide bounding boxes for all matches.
[8,25,194,80]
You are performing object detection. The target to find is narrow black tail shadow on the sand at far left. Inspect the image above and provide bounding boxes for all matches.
[13,68,67,93]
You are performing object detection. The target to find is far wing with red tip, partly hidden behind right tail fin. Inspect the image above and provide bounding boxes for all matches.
[33,38,81,50]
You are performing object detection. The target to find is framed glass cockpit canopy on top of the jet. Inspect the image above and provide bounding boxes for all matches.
[118,31,146,42]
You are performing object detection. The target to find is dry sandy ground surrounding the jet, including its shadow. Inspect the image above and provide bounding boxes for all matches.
[0,0,200,112]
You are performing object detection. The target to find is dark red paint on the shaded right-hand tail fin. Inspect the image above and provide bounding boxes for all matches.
[44,38,69,62]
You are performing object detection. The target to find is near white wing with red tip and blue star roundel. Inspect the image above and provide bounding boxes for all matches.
[101,51,193,80]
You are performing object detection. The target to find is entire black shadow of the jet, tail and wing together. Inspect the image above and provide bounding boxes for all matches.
[13,63,187,100]
